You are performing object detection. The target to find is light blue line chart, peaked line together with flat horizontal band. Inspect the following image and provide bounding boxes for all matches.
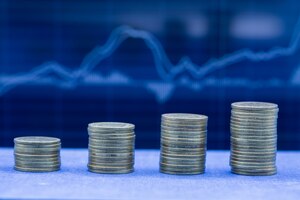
[0,18,300,103]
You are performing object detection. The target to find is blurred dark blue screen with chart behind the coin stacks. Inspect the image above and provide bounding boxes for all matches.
[0,0,300,150]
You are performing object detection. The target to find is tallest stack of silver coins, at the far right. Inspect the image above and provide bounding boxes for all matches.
[230,102,279,175]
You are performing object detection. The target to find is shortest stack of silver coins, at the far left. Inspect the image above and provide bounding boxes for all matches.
[14,136,61,172]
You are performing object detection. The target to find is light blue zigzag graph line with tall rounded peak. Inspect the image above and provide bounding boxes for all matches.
[0,18,300,100]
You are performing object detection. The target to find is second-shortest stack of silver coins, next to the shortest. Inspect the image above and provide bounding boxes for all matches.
[88,122,135,174]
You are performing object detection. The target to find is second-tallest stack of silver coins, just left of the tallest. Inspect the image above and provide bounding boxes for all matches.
[160,113,208,175]
